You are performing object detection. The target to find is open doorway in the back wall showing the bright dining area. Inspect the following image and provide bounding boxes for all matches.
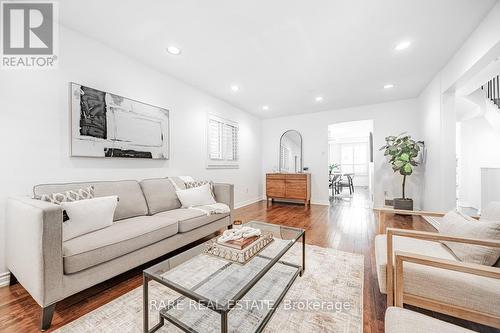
[328,120,373,206]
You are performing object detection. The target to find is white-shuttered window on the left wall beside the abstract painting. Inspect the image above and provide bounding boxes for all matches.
[207,115,239,168]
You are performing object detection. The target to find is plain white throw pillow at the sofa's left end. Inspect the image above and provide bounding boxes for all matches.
[61,195,118,241]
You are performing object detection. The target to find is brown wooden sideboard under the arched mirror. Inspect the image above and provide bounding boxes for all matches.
[266,173,311,205]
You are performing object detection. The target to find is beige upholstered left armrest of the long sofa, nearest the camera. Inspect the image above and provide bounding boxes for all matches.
[6,197,63,307]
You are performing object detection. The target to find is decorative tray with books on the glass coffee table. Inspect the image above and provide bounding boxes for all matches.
[205,233,273,264]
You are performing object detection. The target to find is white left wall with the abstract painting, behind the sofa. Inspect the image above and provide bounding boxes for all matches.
[0,28,262,272]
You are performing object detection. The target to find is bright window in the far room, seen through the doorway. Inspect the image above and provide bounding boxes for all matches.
[340,142,368,175]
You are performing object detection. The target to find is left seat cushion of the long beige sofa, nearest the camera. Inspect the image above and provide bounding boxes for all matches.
[63,215,178,274]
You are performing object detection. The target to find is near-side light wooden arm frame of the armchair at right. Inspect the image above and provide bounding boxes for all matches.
[394,251,500,328]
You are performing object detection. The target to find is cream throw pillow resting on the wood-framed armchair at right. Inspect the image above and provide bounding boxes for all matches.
[439,211,500,266]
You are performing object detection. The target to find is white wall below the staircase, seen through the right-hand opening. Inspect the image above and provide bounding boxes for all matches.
[459,117,500,210]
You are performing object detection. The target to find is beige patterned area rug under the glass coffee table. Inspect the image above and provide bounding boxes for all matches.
[56,244,364,333]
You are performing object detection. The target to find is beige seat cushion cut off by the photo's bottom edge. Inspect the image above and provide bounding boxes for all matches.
[385,307,474,333]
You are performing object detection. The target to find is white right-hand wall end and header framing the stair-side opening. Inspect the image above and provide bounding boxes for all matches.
[418,2,500,211]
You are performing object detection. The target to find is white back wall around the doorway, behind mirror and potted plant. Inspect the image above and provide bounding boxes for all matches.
[262,99,421,207]
